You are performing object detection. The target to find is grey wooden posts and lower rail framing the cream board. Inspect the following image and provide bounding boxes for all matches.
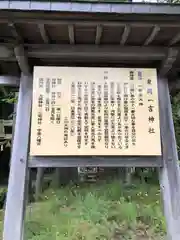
[0,67,180,240]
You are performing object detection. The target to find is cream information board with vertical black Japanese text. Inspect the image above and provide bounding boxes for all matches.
[30,67,161,156]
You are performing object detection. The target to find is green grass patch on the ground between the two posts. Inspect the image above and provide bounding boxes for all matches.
[22,181,165,240]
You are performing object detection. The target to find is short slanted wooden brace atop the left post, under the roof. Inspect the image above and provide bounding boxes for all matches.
[14,45,31,75]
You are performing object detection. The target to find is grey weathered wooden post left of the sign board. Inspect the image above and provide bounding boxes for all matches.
[3,74,32,240]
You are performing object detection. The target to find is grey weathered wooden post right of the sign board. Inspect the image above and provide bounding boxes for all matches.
[158,78,180,240]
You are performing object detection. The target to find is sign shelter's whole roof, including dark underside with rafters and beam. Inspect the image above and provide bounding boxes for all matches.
[0,1,180,81]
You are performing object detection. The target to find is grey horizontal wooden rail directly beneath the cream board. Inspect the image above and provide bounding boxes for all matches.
[29,156,162,168]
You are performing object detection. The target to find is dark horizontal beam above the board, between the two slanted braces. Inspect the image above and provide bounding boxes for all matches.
[26,44,167,60]
